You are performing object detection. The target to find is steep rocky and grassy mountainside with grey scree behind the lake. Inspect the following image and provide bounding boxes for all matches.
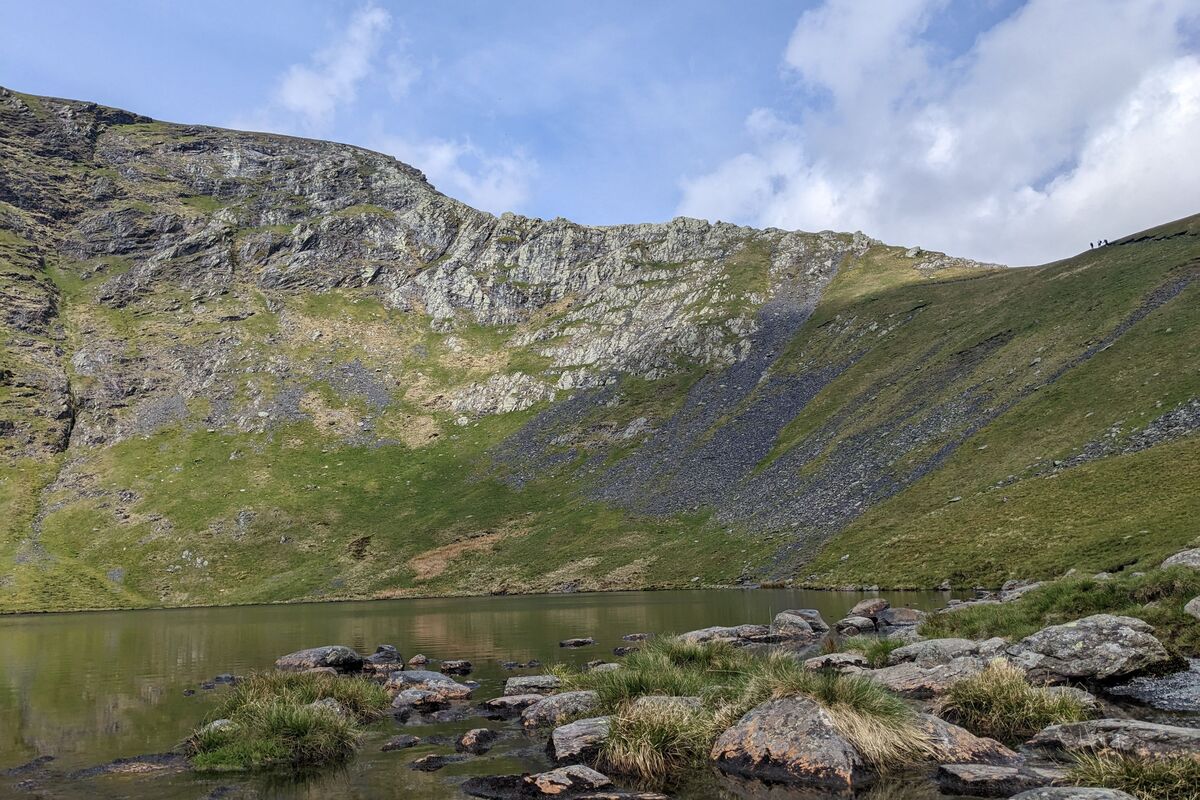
[0,90,1200,609]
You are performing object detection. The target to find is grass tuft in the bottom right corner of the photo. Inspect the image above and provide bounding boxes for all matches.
[1068,753,1200,800]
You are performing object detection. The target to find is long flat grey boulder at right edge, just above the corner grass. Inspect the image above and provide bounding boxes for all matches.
[1028,720,1200,760]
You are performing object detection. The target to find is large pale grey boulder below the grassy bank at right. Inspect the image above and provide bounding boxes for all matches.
[1007,614,1174,682]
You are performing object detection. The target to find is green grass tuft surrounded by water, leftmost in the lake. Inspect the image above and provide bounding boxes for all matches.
[184,673,388,771]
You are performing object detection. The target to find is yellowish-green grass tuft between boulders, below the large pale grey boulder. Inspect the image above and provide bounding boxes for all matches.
[937,660,1091,745]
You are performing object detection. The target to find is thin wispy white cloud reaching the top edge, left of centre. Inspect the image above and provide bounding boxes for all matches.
[275,5,391,128]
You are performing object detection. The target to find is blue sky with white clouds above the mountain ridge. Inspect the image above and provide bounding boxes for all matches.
[0,0,1200,264]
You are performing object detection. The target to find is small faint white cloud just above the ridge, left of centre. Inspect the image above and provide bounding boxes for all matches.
[374,136,538,213]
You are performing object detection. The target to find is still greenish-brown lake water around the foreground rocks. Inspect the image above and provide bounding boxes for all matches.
[0,589,948,800]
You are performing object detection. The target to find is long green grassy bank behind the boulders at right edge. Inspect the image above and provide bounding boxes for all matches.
[920,567,1200,656]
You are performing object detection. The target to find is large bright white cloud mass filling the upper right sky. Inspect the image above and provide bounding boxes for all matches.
[679,0,1200,264]
